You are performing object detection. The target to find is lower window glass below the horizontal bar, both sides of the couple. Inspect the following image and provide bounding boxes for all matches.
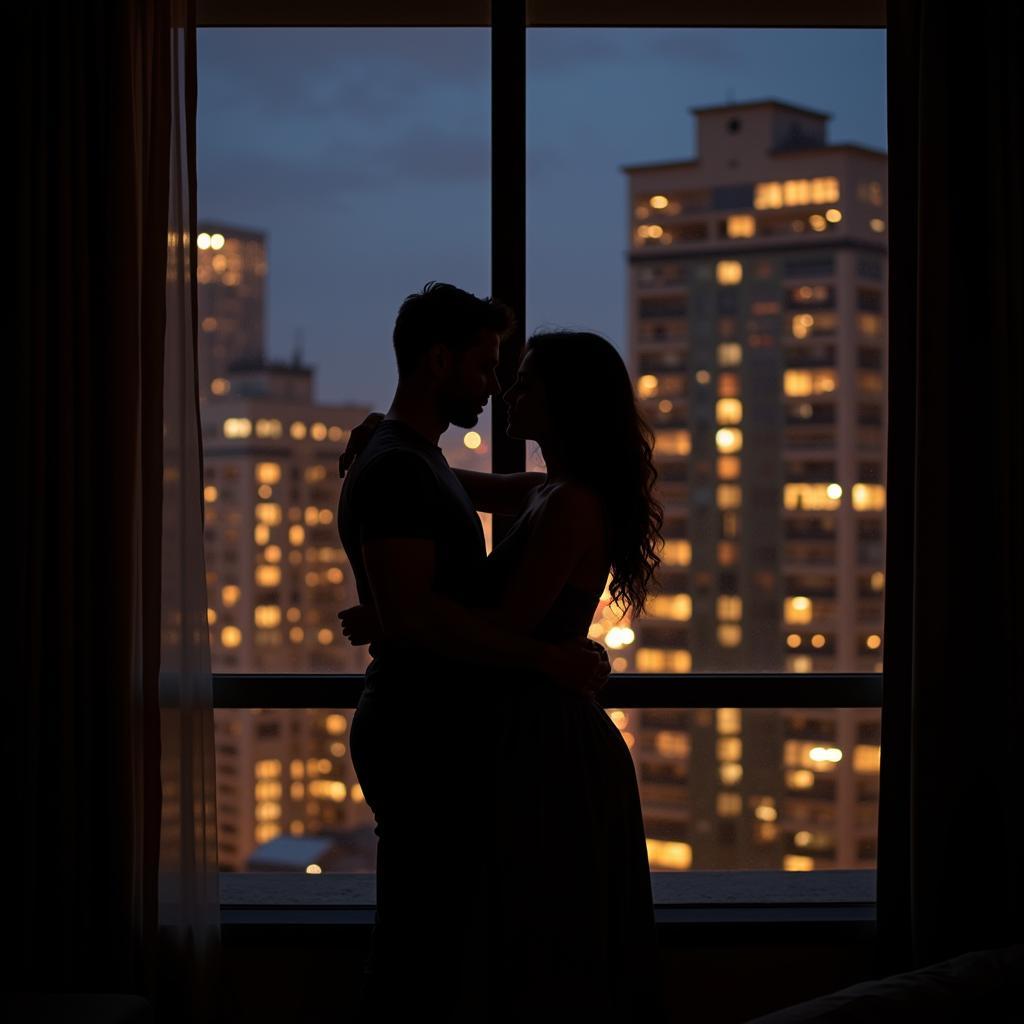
[216,708,881,888]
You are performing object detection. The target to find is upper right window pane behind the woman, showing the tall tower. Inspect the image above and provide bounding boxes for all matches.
[527,29,888,673]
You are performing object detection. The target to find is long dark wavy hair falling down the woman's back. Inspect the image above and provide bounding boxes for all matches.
[526,331,664,618]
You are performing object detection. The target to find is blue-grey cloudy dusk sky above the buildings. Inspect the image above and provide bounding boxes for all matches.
[198,29,888,419]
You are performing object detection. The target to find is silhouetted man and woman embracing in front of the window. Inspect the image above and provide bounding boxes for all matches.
[338,284,664,1022]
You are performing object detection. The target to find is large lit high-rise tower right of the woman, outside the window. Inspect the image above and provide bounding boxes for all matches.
[618,100,888,869]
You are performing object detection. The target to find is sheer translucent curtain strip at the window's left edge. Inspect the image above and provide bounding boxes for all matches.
[159,0,220,1021]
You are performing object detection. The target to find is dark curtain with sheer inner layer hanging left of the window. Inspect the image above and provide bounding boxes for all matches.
[9,0,220,1021]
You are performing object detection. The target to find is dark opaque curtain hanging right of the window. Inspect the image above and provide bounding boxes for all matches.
[878,0,1024,973]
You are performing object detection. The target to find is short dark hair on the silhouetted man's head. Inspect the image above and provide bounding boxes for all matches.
[393,281,514,377]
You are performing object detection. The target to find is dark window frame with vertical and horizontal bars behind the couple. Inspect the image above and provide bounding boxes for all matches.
[197,0,891,917]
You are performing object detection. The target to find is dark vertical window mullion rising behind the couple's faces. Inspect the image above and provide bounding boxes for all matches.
[490,0,526,545]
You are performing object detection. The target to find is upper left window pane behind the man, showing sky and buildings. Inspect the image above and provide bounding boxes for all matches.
[198,29,490,696]
